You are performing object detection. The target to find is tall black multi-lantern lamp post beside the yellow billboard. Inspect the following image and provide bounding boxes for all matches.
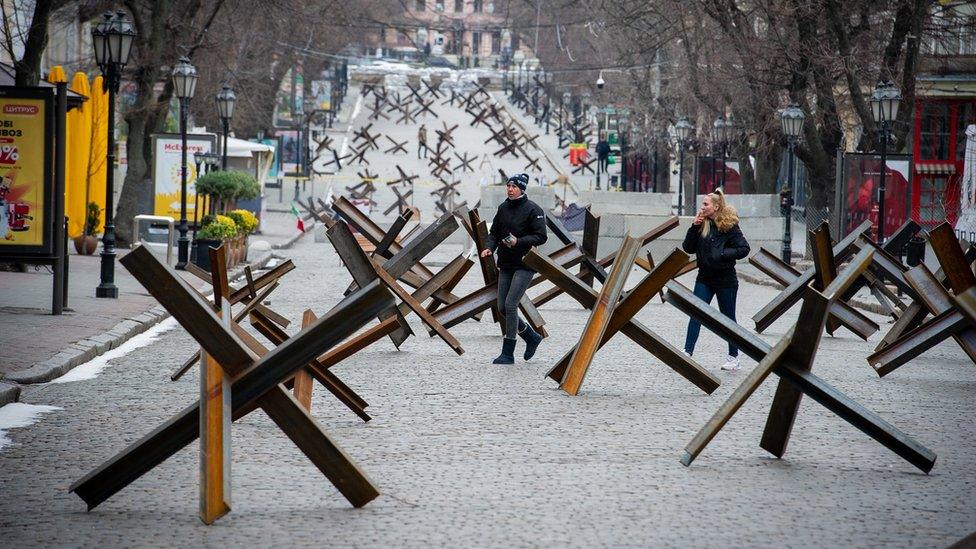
[91,11,136,298]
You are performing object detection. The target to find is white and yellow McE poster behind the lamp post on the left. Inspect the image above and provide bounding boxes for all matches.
[152,134,216,216]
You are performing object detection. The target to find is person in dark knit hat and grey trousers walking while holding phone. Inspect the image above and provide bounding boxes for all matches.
[481,173,547,364]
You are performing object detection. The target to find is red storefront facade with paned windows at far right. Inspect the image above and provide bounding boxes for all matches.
[911,97,976,227]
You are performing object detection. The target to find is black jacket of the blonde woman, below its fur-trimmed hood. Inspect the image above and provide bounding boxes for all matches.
[681,220,749,288]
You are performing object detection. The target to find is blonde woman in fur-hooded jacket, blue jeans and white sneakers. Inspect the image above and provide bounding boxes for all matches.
[681,189,749,371]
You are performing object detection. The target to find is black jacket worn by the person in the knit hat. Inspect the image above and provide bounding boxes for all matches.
[486,193,548,271]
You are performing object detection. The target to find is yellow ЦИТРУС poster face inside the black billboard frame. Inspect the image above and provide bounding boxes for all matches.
[0,97,49,247]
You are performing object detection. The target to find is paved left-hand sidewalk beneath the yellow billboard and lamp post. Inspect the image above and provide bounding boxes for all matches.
[0,213,308,406]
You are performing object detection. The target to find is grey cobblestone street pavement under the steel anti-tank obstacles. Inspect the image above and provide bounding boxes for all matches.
[0,233,976,547]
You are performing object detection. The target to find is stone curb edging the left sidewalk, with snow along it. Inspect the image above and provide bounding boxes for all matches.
[0,250,278,388]
